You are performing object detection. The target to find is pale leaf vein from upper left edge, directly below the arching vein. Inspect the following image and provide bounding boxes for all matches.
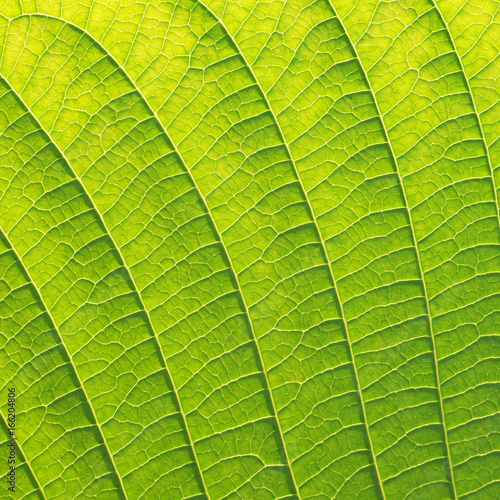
[2,67,210,498]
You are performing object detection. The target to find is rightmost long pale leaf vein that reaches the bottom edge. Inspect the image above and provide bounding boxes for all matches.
[328,0,458,498]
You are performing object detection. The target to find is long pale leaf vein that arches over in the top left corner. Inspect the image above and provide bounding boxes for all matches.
[3,13,292,498]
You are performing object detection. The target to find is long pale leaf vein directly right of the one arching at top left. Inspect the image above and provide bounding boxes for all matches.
[193,0,385,499]
